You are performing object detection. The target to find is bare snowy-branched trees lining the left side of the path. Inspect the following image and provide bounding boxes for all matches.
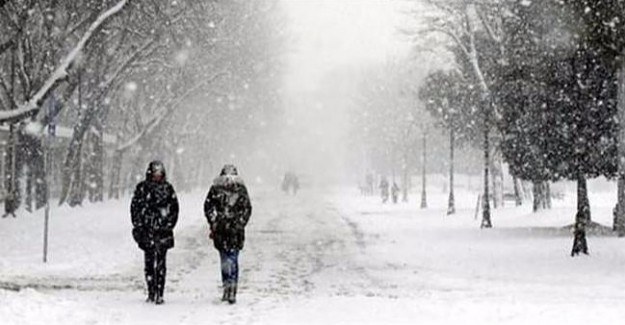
[0,0,283,213]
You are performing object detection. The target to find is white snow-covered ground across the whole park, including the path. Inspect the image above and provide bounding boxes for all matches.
[0,181,625,324]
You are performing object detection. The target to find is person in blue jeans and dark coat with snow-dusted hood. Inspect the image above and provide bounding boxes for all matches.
[204,165,252,304]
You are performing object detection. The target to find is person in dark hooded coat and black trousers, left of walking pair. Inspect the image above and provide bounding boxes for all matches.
[130,161,178,305]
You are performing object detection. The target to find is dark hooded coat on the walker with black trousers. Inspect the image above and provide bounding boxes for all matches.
[130,162,178,250]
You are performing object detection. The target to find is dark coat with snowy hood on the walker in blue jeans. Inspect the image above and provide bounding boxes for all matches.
[204,175,252,250]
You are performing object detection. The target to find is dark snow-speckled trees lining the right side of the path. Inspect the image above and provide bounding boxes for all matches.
[420,0,625,255]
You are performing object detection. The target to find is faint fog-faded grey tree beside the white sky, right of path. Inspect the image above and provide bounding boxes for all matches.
[351,62,426,200]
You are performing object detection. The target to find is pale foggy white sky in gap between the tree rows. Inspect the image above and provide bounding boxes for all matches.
[282,0,410,180]
